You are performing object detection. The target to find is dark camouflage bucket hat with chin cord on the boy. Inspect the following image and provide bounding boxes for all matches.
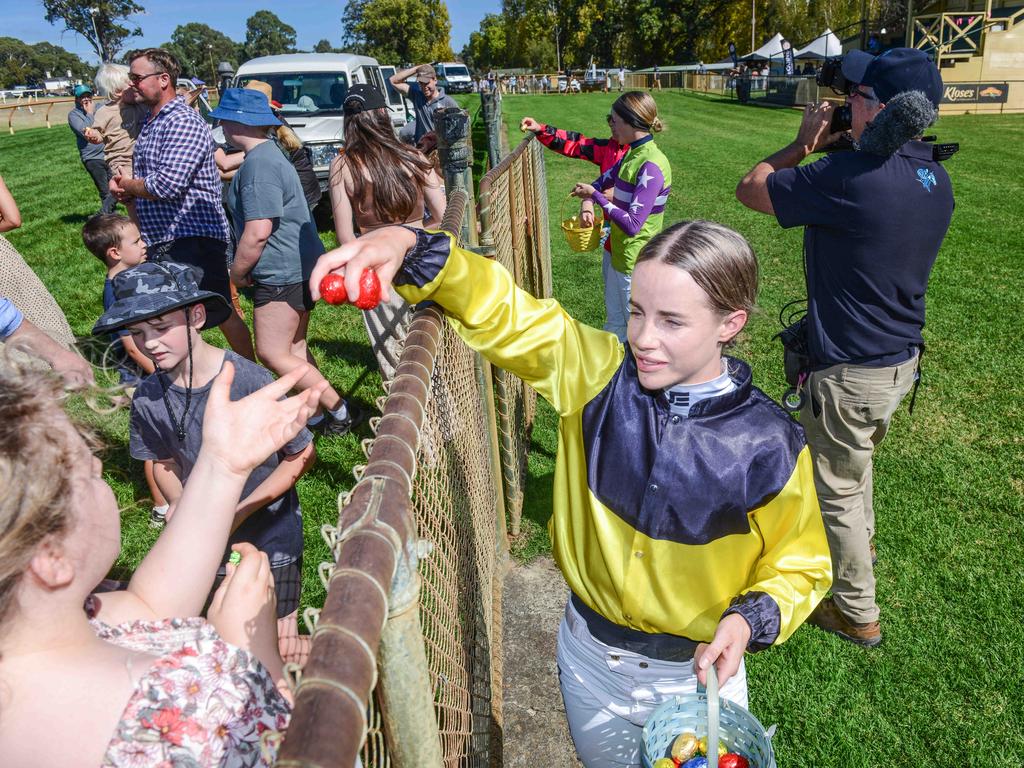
[92,261,231,336]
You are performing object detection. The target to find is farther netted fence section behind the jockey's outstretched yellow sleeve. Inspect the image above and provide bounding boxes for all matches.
[479,136,551,536]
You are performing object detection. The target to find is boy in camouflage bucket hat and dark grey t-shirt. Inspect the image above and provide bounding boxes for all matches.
[92,262,315,660]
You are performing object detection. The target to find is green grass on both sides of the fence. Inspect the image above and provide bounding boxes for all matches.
[0,92,1024,768]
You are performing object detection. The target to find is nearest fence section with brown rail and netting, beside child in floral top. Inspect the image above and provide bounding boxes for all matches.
[278,191,507,768]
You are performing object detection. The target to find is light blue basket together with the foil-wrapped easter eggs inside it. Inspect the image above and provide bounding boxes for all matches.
[640,665,776,768]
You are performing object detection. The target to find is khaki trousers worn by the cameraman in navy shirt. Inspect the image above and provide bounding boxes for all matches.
[800,355,918,624]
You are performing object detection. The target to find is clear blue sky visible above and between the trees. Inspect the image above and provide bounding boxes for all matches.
[7,0,501,62]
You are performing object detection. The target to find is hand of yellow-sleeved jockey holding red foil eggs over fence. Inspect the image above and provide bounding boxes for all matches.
[309,226,416,301]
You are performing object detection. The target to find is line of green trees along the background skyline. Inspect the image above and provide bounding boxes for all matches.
[29,0,913,91]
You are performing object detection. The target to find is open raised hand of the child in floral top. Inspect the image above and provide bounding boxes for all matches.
[200,362,327,477]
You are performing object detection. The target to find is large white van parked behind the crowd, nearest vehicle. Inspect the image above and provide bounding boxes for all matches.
[233,53,386,189]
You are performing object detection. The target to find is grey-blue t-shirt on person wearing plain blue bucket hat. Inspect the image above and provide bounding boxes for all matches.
[227,141,324,286]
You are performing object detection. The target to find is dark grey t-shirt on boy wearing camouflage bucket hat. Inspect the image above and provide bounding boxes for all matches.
[128,350,312,567]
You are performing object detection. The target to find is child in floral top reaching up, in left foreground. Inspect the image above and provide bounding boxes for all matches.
[0,358,319,768]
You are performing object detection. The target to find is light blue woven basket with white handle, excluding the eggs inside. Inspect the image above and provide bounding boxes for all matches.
[640,665,776,768]
